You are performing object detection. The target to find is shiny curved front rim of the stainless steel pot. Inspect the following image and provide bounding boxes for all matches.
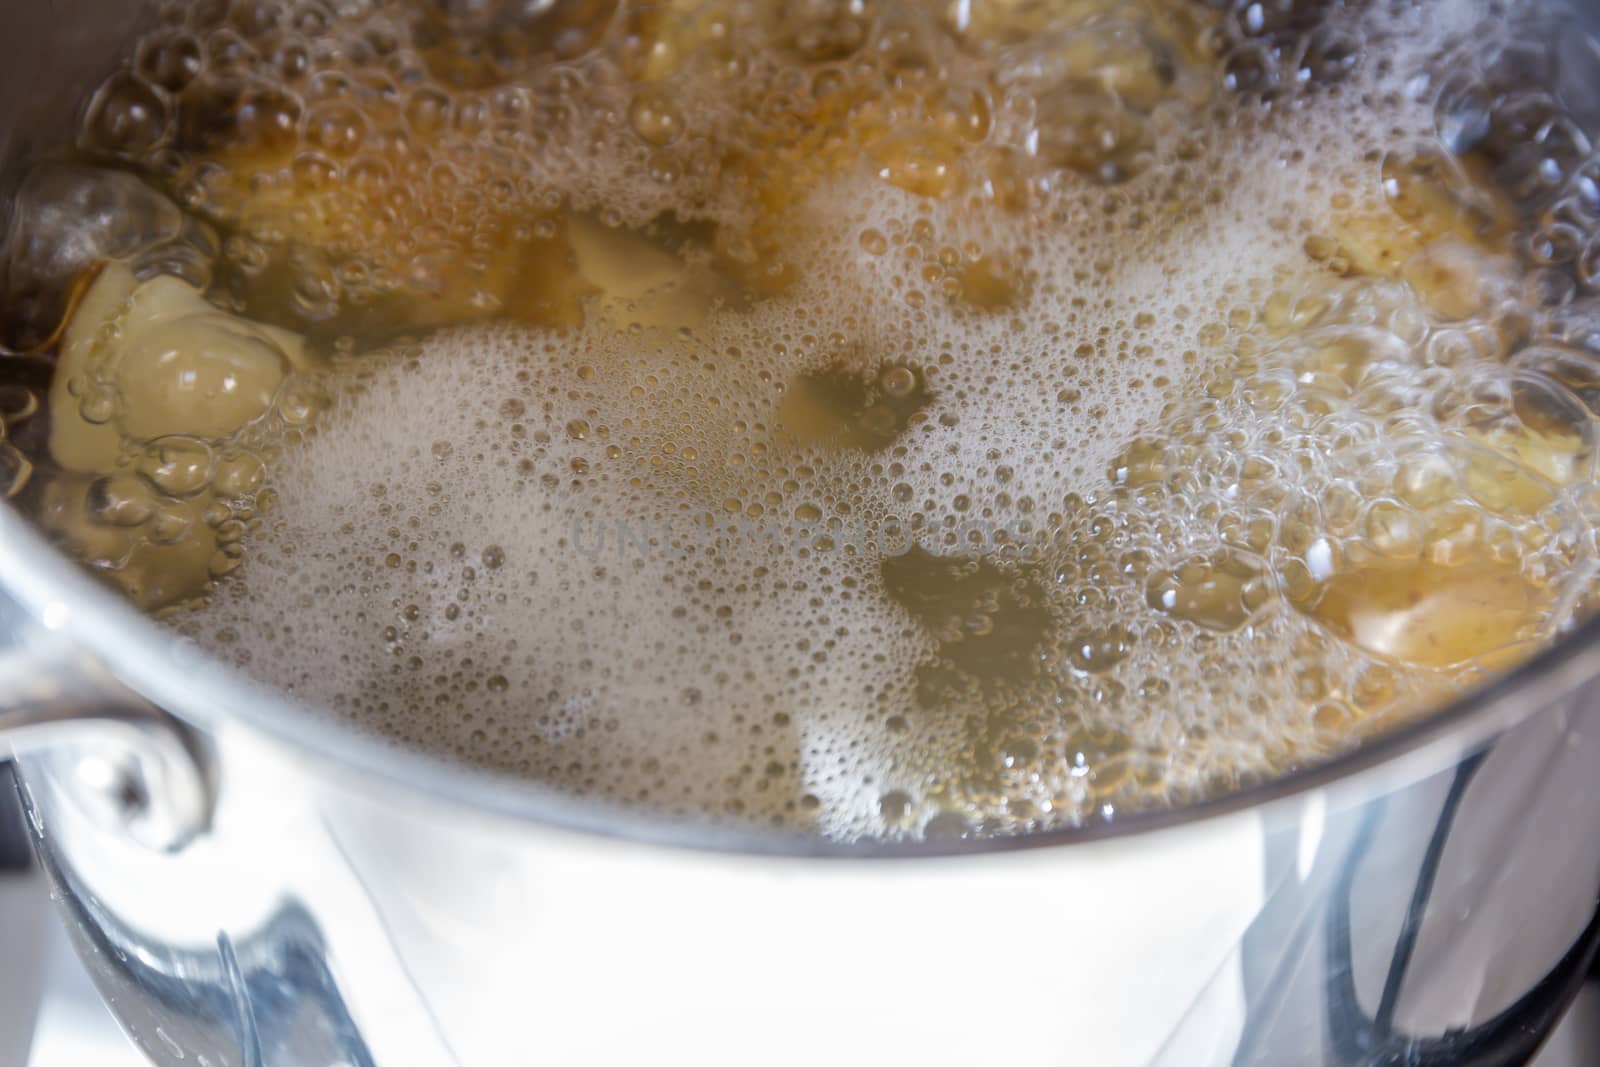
[0,492,1600,859]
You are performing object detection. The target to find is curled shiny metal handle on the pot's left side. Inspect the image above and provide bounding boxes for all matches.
[0,601,216,851]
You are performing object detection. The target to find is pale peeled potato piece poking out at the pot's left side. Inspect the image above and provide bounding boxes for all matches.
[42,264,307,611]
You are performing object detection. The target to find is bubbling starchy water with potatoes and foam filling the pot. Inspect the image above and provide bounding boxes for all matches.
[0,0,1600,840]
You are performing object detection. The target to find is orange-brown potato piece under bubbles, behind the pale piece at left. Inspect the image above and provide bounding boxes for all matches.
[178,98,594,342]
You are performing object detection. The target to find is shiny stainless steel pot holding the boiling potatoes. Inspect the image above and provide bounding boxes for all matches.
[0,0,1600,1067]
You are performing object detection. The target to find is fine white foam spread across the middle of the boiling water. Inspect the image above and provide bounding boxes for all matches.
[165,3,1587,837]
